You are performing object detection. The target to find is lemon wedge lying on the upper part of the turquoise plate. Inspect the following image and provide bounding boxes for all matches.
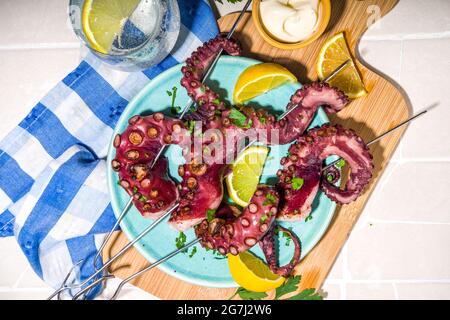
[233,63,297,104]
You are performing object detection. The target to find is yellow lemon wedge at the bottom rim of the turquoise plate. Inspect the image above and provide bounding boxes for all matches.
[228,251,285,292]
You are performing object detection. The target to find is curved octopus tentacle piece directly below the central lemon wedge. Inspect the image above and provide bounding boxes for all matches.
[195,185,279,255]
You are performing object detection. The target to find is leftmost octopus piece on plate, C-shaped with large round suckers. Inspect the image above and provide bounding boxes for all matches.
[111,113,184,218]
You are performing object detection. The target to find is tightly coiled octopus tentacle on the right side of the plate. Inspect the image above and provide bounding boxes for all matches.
[278,124,374,220]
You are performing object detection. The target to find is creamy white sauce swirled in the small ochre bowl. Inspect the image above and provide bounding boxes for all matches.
[260,0,319,43]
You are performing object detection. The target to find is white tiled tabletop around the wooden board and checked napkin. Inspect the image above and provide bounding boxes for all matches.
[0,0,450,299]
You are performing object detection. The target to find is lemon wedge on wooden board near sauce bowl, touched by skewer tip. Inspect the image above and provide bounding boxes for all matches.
[317,32,367,99]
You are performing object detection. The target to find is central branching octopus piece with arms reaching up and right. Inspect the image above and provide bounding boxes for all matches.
[170,36,348,231]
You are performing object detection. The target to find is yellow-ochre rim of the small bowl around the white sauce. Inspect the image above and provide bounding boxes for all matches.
[252,0,331,50]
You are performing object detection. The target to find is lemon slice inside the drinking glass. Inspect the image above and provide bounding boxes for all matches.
[81,0,140,54]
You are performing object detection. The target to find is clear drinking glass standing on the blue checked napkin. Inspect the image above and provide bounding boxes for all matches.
[69,0,180,71]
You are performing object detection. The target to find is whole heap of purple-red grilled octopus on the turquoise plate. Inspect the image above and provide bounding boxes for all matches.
[111,36,373,276]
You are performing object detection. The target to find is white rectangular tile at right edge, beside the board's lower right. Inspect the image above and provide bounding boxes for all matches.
[348,223,450,281]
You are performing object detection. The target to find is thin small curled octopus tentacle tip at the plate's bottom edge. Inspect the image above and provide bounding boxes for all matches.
[259,225,301,277]
